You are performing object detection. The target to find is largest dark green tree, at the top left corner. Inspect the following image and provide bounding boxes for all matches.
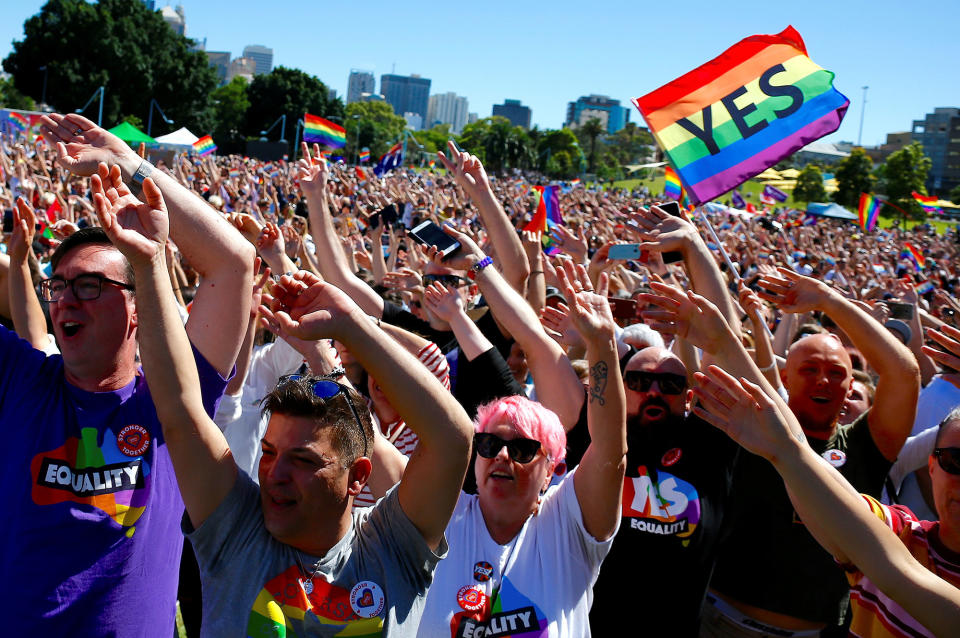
[3,0,217,133]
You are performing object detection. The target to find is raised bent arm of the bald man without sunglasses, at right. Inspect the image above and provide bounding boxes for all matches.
[760,268,920,461]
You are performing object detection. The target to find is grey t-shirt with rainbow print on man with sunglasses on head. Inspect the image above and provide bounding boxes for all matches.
[183,472,447,638]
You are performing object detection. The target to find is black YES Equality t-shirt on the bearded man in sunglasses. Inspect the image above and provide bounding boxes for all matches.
[590,416,740,636]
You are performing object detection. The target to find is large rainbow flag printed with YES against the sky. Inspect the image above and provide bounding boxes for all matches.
[633,27,850,204]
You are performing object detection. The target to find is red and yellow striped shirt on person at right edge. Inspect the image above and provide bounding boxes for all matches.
[847,494,960,638]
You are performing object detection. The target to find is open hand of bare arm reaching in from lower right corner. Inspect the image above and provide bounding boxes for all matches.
[693,366,804,460]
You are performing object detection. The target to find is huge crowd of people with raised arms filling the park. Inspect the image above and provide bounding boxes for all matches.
[0,114,960,638]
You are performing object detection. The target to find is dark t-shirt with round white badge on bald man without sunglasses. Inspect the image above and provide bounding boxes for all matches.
[710,412,892,625]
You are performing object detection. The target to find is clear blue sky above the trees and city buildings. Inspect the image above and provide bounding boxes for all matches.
[0,0,960,144]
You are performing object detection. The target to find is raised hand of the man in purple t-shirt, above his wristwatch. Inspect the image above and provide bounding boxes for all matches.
[40,113,140,176]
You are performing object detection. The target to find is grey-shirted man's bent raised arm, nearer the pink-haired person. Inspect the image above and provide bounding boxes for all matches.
[264,271,473,548]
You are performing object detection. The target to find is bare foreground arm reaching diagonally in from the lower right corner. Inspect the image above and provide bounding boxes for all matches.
[694,367,960,636]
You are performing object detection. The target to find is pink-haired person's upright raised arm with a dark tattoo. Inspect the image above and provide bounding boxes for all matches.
[558,266,627,541]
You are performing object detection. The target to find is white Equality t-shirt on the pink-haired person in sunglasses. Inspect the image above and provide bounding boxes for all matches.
[417,470,620,638]
